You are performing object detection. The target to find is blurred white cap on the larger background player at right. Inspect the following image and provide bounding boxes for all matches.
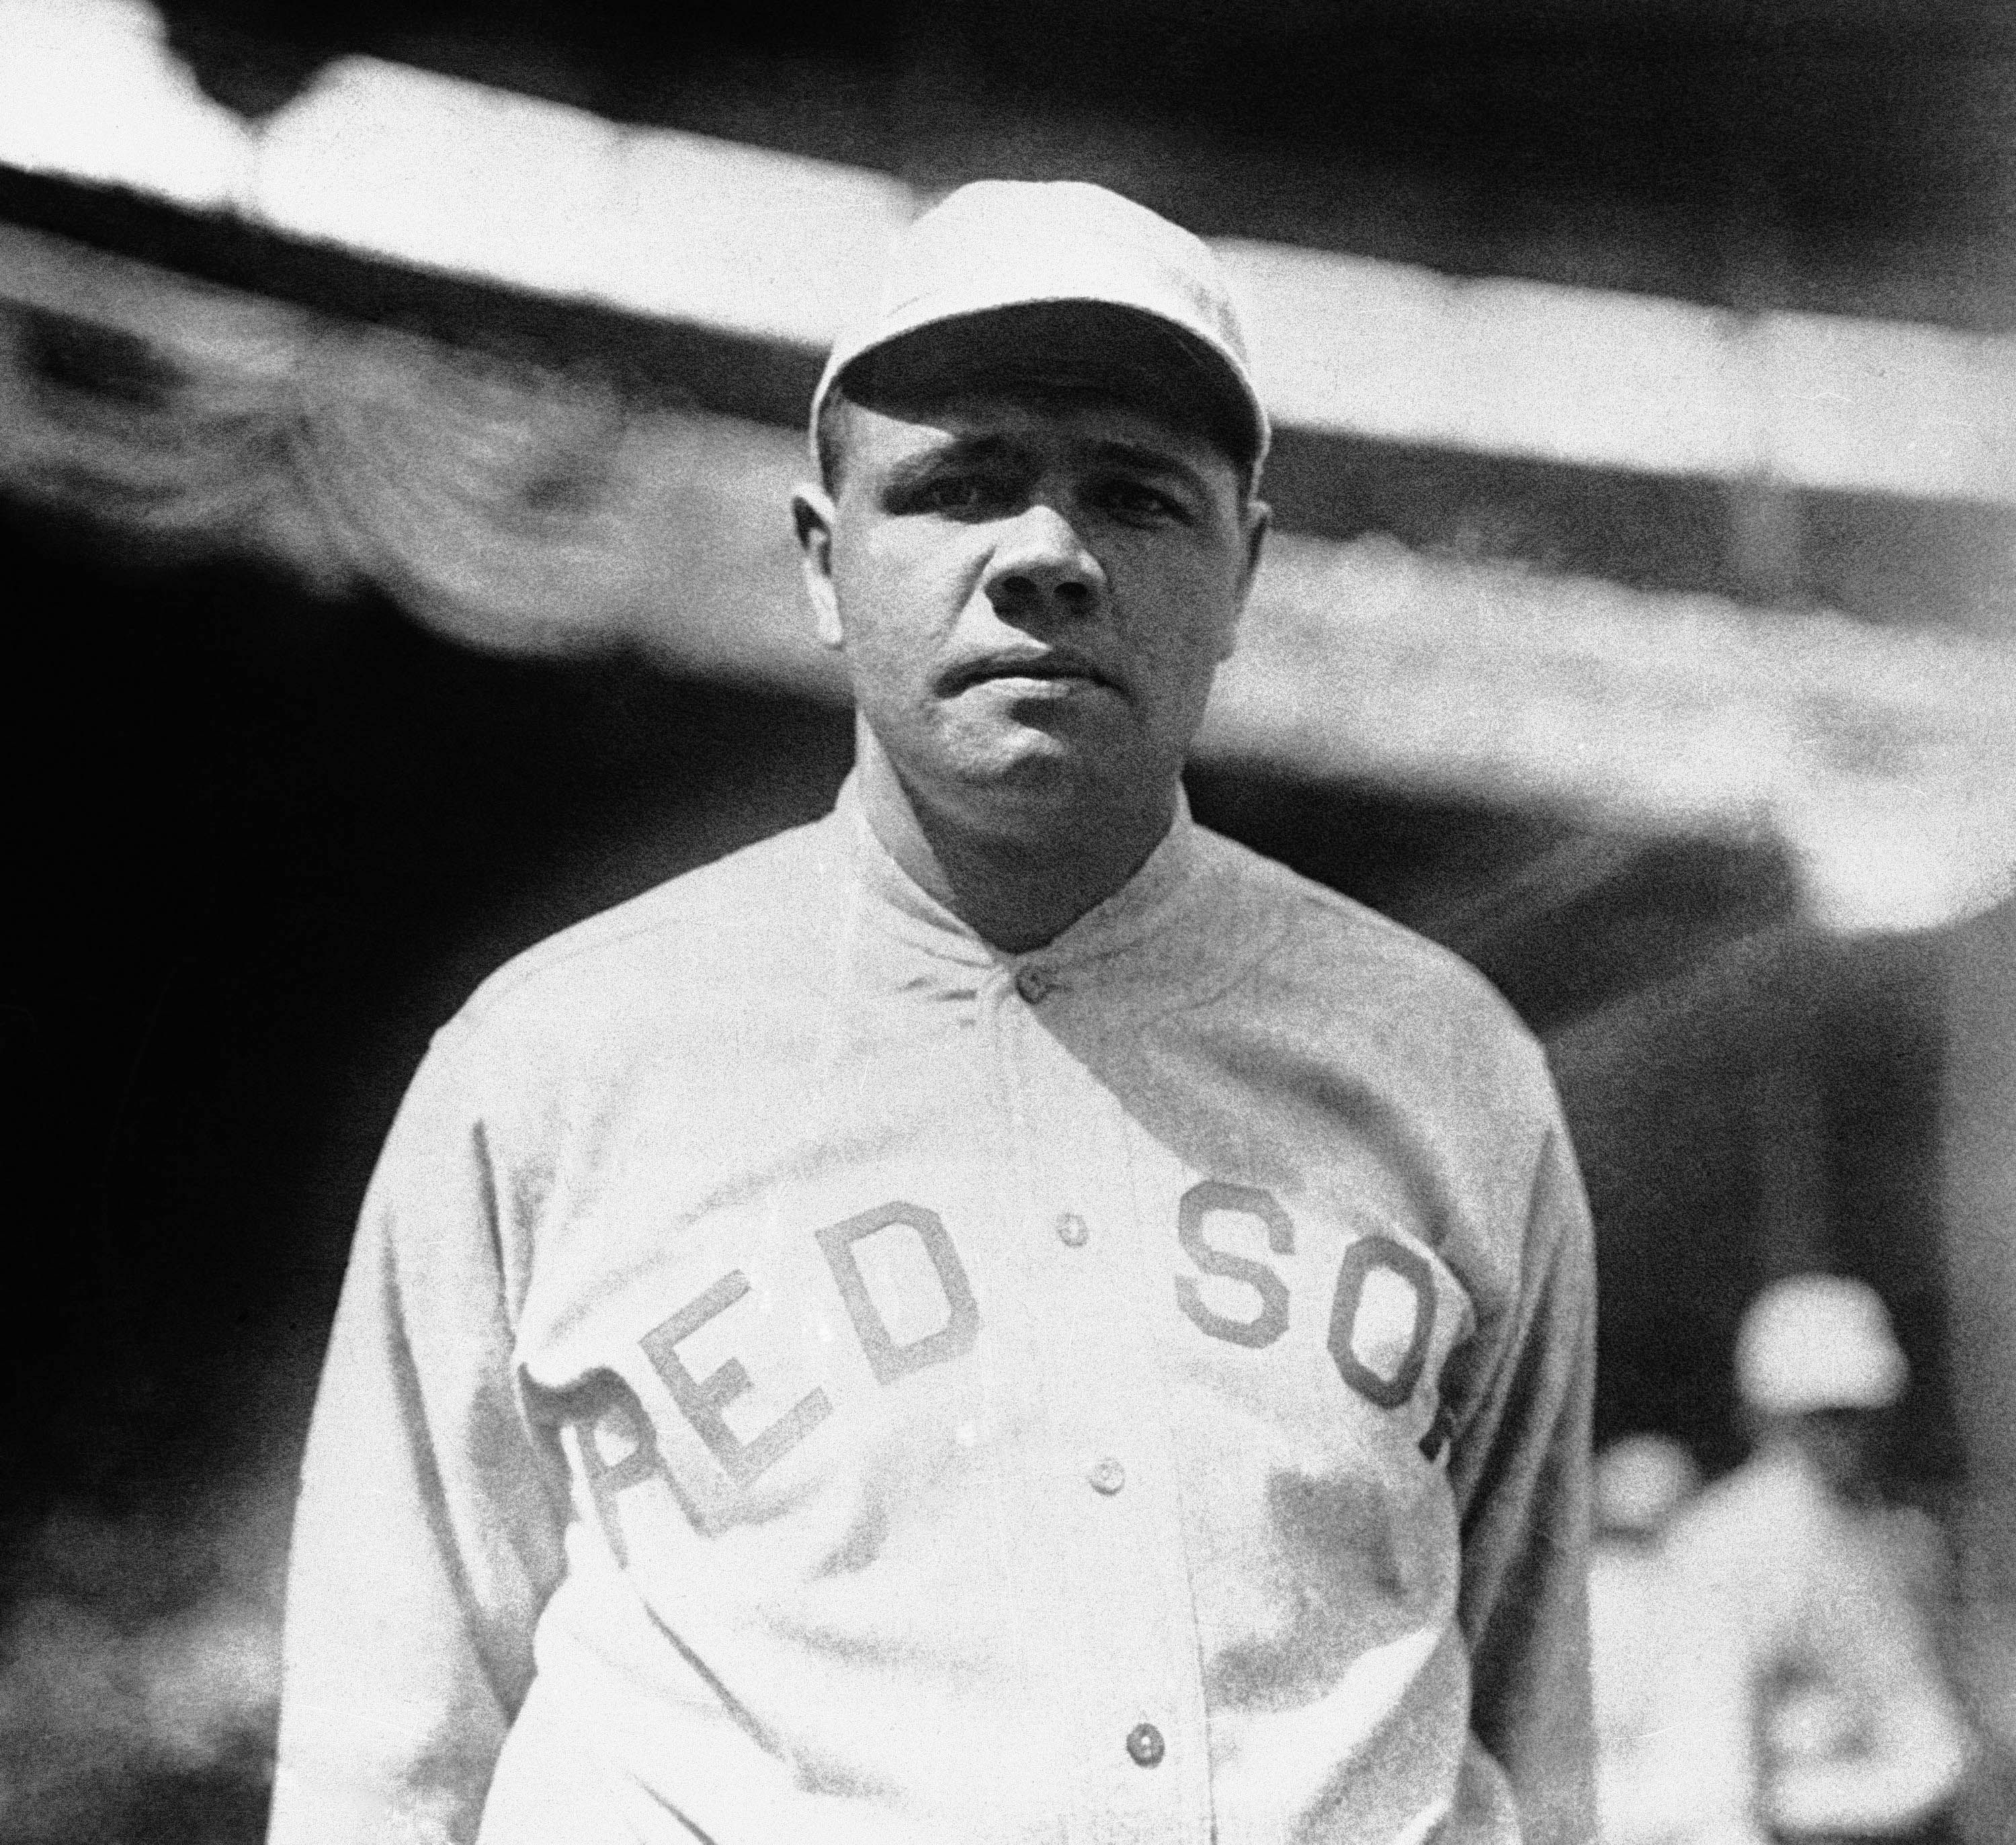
[1736,1275,1909,1416]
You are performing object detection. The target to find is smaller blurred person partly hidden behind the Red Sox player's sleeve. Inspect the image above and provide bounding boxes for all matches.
[1589,1434,1768,1845]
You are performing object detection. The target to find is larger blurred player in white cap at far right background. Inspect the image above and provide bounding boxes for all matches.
[1671,1275,1970,1845]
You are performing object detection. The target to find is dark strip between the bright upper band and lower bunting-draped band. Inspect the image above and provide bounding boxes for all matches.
[15,157,2016,633]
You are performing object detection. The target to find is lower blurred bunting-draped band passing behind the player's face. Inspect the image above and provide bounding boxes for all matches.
[0,228,2016,930]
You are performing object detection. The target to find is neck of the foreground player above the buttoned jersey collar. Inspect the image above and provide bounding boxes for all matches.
[857,736,1175,954]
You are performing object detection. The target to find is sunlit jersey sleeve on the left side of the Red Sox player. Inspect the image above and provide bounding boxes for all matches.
[268,1053,562,1845]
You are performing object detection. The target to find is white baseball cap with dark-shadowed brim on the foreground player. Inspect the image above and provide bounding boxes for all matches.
[812,179,1270,478]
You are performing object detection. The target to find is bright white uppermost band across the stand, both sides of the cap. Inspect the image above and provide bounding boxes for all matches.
[0,14,2016,504]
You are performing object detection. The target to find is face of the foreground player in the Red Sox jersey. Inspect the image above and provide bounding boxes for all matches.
[798,395,1266,812]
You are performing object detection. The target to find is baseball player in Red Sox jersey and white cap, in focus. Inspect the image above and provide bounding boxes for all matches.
[272,181,1593,1845]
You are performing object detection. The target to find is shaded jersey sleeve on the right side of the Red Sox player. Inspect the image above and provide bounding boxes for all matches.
[1450,1121,1595,1845]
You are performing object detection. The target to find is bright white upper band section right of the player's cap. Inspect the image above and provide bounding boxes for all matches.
[1220,242,2016,502]
